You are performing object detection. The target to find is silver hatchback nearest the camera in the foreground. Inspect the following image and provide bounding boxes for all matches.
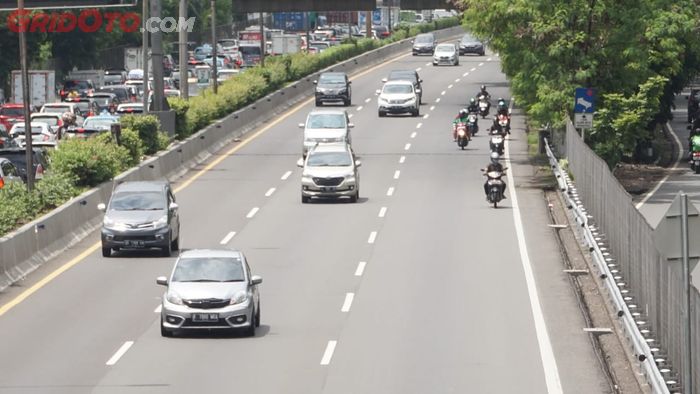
[156,249,262,337]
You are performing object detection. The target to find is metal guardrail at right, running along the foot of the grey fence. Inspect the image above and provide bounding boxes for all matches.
[544,138,677,394]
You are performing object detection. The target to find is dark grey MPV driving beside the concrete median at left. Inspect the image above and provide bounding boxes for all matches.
[98,181,180,257]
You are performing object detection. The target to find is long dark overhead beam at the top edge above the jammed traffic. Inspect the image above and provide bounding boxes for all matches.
[233,0,377,13]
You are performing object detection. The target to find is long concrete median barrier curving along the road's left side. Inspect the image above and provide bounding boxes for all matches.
[0,23,463,290]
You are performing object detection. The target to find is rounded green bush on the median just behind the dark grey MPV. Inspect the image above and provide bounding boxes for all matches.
[51,138,130,186]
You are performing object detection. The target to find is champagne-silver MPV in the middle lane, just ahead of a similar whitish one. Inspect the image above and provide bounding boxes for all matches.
[297,143,362,203]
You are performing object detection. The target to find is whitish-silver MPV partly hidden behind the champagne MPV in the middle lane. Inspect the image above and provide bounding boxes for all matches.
[299,109,355,157]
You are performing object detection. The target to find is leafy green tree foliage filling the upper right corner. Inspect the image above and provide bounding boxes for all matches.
[463,0,700,163]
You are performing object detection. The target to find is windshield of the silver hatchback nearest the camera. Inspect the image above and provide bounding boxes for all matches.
[171,257,245,282]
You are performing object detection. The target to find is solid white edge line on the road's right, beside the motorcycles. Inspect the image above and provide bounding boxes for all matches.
[505,100,563,394]
